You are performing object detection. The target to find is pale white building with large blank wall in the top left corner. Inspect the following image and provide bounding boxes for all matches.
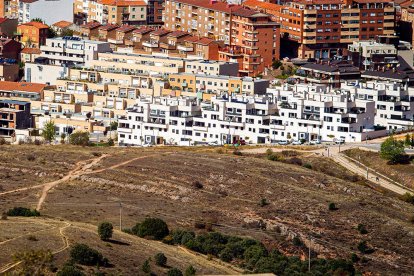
[19,0,73,25]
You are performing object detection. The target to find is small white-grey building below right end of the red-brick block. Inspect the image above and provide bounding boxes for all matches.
[348,41,399,70]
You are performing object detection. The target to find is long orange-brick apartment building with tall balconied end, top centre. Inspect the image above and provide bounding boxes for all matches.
[164,0,280,76]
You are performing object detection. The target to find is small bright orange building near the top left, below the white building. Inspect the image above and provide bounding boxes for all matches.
[17,21,49,48]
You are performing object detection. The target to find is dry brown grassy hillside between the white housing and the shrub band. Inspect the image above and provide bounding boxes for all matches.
[0,146,414,275]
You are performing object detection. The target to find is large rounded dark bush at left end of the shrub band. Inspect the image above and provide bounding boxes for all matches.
[131,218,170,240]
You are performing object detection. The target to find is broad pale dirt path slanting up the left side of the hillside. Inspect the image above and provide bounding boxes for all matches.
[36,154,108,210]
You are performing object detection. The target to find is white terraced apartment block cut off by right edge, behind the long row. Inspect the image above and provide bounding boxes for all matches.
[341,81,414,130]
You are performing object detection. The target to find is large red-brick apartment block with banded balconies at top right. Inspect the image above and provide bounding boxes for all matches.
[244,0,395,59]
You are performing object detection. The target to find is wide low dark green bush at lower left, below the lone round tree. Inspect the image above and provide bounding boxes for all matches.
[70,243,108,266]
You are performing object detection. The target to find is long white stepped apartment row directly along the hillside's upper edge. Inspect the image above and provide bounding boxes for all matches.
[118,85,385,146]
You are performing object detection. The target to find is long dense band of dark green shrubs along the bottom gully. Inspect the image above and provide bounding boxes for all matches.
[164,226,355,275]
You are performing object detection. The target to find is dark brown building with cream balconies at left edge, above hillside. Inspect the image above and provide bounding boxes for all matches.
[0,100,32,138]
